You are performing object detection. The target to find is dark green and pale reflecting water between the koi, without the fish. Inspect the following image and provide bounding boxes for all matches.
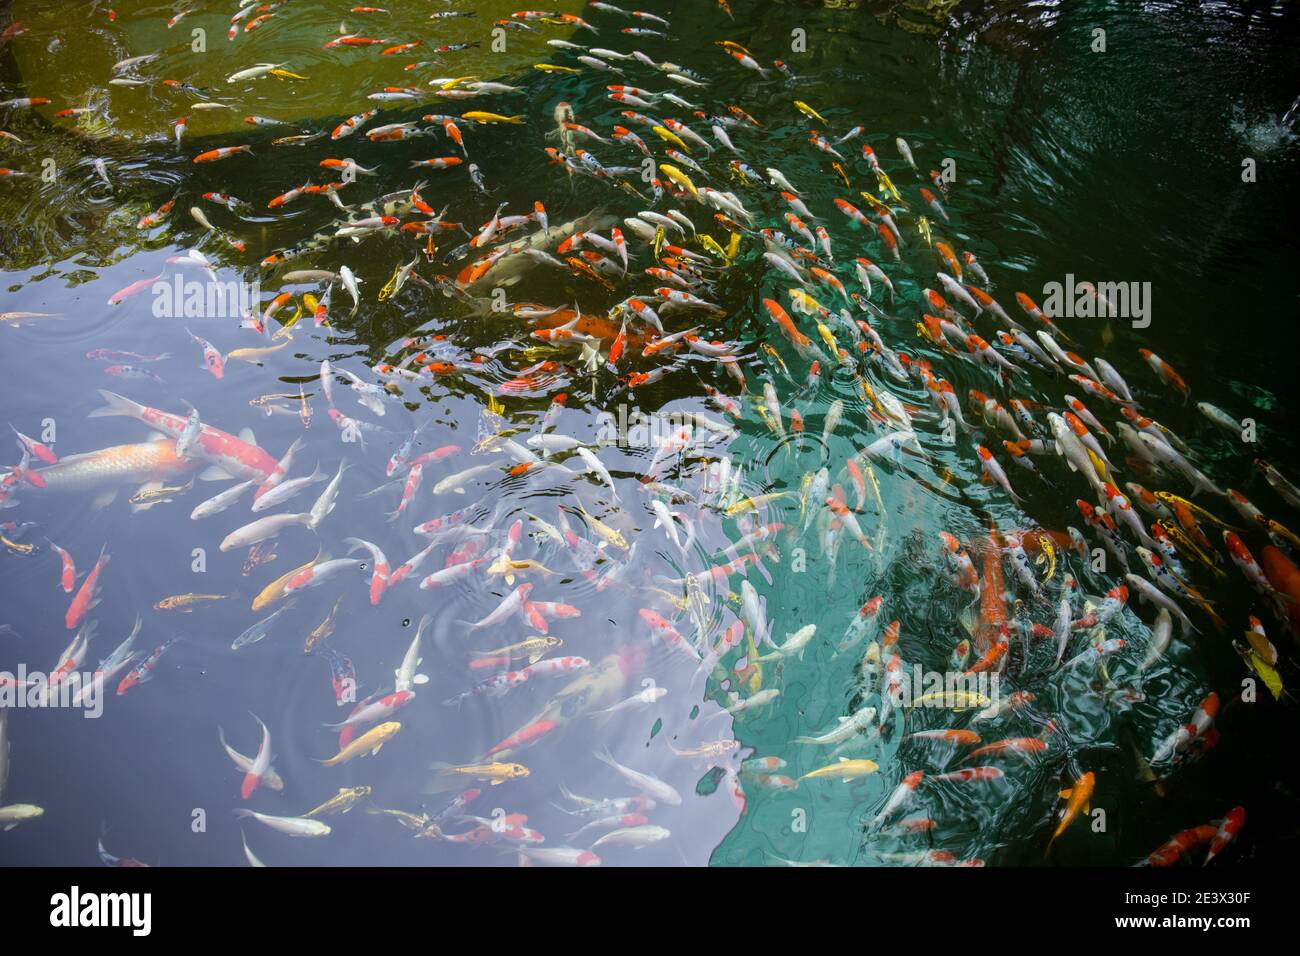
[0,0,1300,865]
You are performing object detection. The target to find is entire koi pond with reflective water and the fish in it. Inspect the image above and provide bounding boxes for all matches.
[0,0,1300,866]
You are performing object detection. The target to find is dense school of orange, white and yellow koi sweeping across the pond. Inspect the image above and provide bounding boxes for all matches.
[0,3,1300,865]
